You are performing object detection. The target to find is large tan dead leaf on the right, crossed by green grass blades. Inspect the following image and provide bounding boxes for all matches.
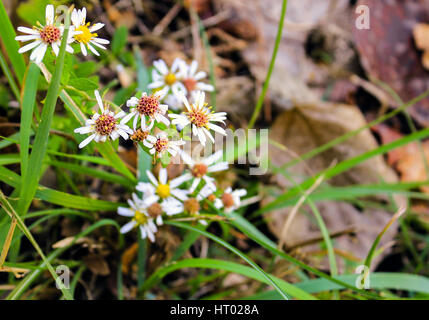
[263,102,403,270]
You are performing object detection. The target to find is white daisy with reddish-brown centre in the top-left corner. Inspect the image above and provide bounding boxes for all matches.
[15,4,80,63]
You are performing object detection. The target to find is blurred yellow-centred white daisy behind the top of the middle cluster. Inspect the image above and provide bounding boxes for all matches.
[148,58,186,97]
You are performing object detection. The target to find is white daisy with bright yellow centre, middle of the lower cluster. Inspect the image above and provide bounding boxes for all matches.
[136,168,188,212]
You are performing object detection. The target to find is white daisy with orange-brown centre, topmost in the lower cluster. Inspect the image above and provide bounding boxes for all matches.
[179,150,228,193]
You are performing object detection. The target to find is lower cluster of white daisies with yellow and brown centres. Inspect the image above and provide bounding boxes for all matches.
[118,157,246,242]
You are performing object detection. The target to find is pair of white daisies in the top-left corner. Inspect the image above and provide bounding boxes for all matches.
[15,5,109,63]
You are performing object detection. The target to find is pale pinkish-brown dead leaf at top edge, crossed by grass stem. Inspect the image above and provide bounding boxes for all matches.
[213,0,352,108]
